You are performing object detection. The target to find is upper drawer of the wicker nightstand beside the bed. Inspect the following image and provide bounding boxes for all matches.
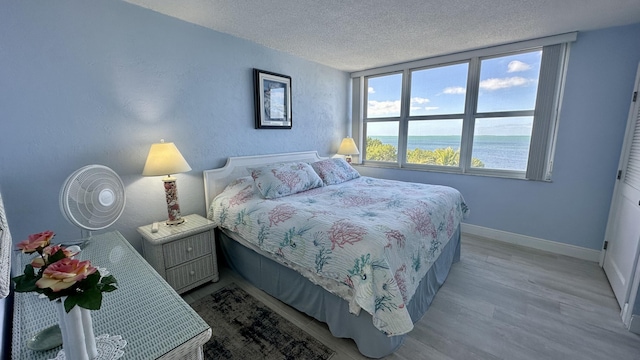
[162,231,213,269]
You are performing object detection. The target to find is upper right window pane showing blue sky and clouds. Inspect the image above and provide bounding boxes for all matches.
[477,50,542,113]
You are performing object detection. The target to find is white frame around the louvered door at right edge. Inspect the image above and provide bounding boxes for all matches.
[598,63,640,329]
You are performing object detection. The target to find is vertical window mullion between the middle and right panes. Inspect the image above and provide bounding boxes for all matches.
[460,57,480,173]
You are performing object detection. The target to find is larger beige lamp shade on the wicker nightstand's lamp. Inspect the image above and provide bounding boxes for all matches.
[142,140,191,176]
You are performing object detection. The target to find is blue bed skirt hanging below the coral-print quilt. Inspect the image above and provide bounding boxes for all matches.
[218,226,460,358]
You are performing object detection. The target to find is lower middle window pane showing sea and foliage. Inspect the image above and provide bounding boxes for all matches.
[407,119,462,166]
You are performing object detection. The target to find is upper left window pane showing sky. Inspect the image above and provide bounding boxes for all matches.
[367,73,402,118]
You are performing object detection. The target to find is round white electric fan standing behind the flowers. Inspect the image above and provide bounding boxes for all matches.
[60,165,126,245]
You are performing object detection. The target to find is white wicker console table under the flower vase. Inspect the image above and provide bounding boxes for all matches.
[12,232,211,359]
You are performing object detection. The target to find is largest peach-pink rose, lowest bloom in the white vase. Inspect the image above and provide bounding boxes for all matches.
[36,258,97,292]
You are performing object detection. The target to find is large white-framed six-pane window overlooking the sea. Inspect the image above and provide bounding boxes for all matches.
[352,34,575,180]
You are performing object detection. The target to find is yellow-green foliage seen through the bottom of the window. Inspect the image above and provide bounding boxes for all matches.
[367,137,484,167]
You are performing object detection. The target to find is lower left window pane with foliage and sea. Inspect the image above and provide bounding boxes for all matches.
[365,121,399,162]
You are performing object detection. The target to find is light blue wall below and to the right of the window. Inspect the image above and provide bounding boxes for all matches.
[358,24,640,249]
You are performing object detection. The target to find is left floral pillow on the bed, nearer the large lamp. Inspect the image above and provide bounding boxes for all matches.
[247,162,323,199]
